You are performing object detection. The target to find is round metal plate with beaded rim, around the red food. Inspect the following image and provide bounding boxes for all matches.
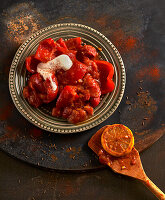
[9,23,126,134]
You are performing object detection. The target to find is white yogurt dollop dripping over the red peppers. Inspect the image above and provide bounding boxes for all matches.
[37,54,73,90]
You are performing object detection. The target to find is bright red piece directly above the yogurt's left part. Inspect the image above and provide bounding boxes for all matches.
[35,38,57,62]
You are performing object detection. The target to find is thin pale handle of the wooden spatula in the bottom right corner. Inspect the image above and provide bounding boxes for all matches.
[142,177,165,200]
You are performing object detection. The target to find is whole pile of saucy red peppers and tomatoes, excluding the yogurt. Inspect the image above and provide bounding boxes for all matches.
[23,37,115,123]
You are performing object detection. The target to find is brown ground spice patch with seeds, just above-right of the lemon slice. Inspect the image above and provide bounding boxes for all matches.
[120,91,158,132]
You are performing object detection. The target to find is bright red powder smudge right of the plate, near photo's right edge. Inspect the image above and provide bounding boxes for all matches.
[136,65,161,81]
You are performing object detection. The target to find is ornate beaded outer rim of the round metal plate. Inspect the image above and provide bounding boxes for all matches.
[9,23,126,134]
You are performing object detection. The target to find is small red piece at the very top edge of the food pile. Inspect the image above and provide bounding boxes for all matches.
[65,37,82,50]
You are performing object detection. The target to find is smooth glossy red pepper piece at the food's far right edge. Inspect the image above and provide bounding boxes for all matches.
[95,60,115,94]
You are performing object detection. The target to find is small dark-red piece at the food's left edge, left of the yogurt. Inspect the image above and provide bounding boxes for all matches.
[25,55,40,74]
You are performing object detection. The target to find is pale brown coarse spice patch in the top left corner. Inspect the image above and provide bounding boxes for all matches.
[2,3,45,44]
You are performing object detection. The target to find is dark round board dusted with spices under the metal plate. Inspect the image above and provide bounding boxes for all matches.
[0,1,165,170]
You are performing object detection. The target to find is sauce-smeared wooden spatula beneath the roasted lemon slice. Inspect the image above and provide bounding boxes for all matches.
[88,126,165,200]
